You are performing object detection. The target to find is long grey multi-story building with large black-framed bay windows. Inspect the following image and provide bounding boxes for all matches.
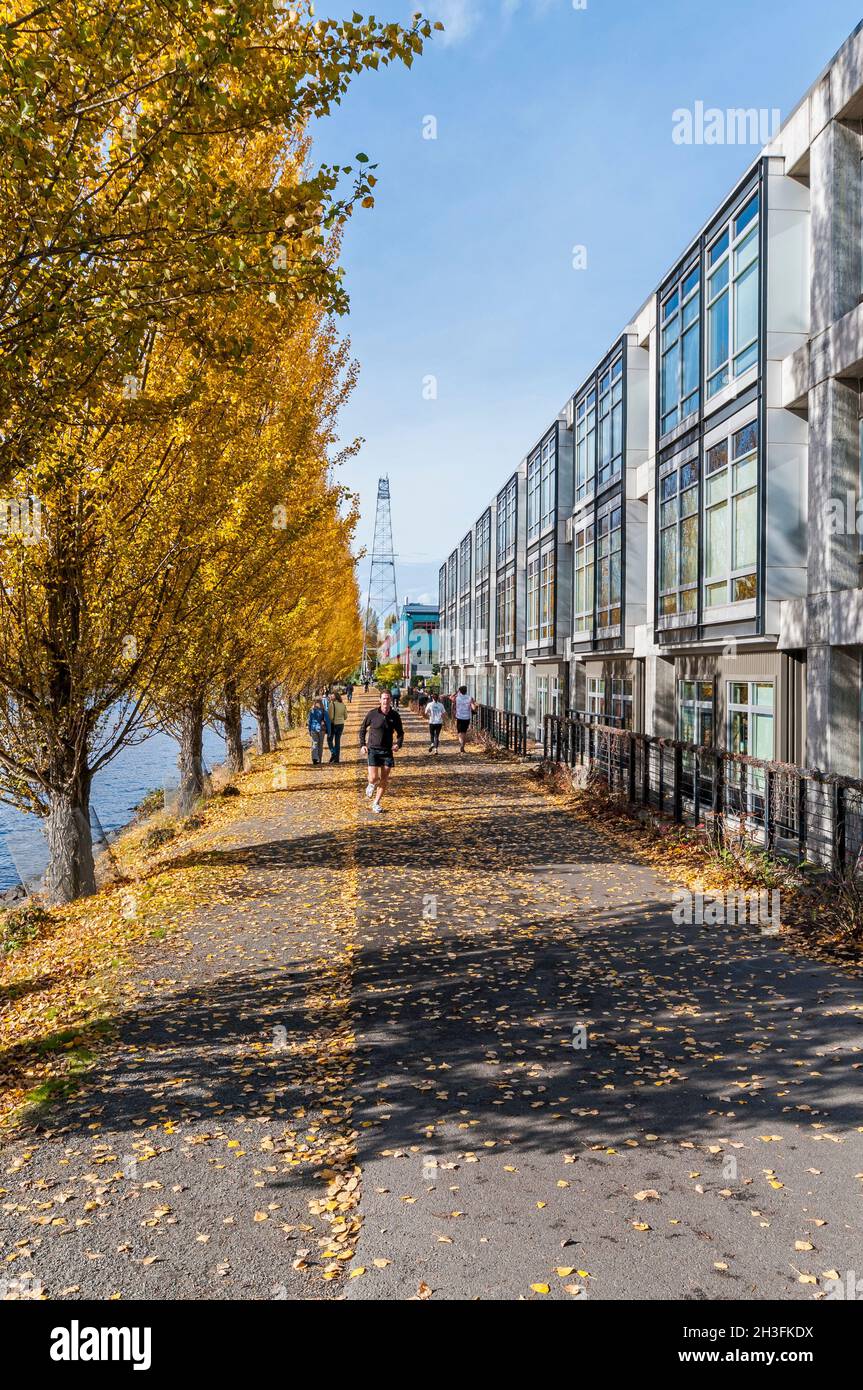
[442,26,863,776]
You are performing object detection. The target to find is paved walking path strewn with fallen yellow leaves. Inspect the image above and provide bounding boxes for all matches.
[0,692,863,1301]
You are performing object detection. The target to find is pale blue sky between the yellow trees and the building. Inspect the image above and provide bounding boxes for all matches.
[314,0,860,598]
